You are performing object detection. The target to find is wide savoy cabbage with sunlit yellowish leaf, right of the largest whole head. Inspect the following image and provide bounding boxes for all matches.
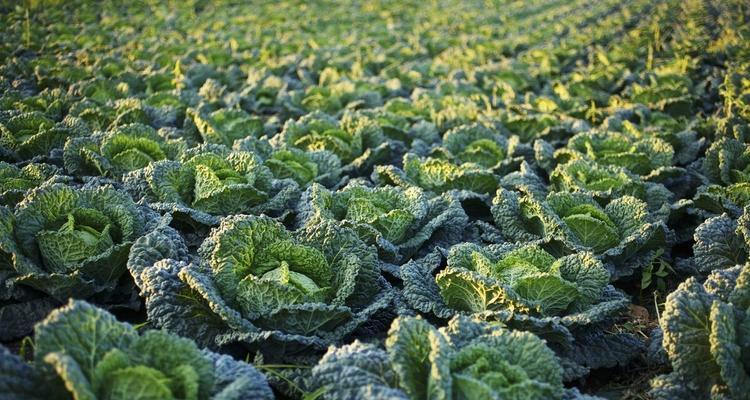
[401,243,609,317]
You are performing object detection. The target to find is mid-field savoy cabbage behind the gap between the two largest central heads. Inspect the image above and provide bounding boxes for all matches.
[298,181,468,262]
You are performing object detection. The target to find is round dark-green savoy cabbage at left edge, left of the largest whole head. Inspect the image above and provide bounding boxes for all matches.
[0,184,155,301]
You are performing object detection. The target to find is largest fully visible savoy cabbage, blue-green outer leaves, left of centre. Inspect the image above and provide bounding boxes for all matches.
[128,215,392,357]
